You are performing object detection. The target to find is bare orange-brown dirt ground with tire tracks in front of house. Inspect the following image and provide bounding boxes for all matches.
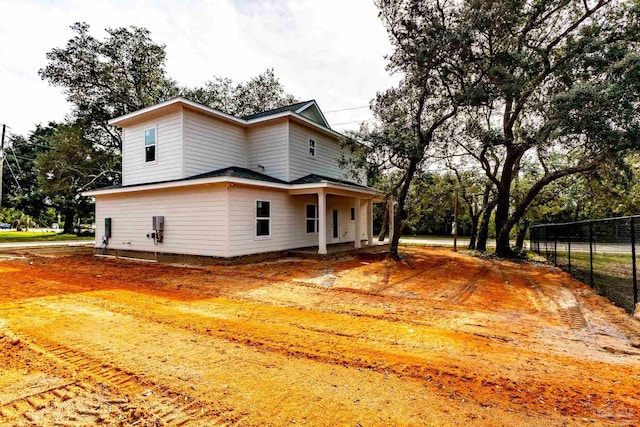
[0,248,640,426]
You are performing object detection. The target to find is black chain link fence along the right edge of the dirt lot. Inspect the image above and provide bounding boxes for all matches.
[529,216,640,313]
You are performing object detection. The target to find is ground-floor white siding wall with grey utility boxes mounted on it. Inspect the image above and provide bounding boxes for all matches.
[96,184,229,257]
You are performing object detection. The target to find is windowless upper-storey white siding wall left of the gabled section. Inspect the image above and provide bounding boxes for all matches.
[184,109,248,178]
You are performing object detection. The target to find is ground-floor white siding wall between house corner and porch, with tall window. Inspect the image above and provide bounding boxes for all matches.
[229,186,318,256]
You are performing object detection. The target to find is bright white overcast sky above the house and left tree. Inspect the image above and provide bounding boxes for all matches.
[0,0,398,135]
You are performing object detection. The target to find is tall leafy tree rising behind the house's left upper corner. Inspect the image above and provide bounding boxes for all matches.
[39,22,178,153]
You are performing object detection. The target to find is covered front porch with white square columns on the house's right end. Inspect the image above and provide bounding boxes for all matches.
[289,182,393,256]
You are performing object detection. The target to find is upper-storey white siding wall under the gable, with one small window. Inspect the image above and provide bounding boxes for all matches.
[289,122,366,185]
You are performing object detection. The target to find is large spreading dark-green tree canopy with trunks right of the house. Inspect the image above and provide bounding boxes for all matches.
[362,0,640,256]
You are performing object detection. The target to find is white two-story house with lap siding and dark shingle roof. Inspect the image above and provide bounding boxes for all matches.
[83,98,388,258]
